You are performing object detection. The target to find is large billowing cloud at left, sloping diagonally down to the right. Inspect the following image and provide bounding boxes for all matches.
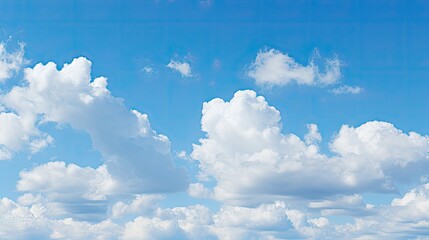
[0,57,187,193]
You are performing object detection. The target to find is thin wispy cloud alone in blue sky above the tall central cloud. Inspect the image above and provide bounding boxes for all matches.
[247,49,341,86]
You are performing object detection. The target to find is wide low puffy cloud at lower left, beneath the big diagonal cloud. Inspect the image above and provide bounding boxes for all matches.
[17,162,119,221]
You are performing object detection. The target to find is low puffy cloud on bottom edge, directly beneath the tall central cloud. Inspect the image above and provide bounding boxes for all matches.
[212,201,329,239]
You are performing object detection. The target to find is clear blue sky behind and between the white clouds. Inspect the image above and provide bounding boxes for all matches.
[0,0,429,239]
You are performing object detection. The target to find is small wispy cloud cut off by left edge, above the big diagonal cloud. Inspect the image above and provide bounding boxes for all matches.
[0,43,25,83]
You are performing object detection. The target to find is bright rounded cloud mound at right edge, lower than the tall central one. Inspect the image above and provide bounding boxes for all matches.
[330,121,429,167]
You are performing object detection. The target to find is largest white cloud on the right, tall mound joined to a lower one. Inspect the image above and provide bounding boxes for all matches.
[191,90,429,204]
